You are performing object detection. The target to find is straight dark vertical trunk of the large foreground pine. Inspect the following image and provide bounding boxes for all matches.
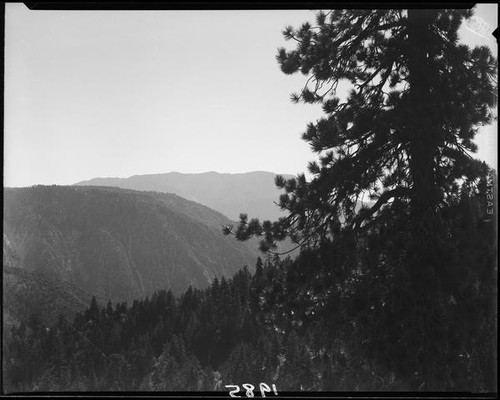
[407,10,446,390]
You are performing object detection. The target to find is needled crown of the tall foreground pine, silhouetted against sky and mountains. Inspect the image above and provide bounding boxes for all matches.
[225,10,496,250]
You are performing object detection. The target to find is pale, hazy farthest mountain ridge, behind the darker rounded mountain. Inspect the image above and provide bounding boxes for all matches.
[75,171,292,220]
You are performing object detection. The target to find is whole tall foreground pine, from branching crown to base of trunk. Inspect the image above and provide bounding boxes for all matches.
[225,9,497,390]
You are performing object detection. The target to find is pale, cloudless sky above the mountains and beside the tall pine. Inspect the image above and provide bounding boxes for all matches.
[4,4,497,187]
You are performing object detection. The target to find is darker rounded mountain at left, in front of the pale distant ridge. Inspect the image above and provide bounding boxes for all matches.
[3,186,257,308]
